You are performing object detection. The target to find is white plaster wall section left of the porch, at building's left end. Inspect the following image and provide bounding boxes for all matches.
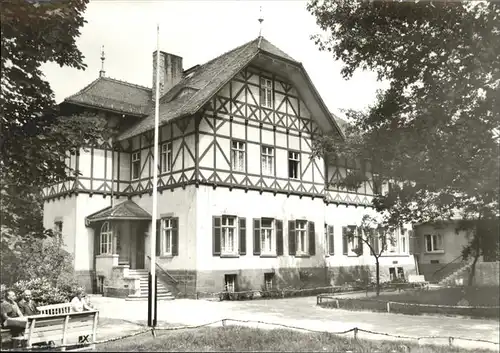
[43,196,76,255]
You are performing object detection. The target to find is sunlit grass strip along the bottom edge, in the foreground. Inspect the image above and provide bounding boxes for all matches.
[96,326,492,353]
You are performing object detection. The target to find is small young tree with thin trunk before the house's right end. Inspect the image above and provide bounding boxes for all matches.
[347,215,395,296]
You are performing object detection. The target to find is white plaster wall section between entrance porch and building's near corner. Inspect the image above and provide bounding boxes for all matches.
[132,185,197,271]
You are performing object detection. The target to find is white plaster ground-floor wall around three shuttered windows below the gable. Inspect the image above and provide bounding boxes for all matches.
[196,186,324,271]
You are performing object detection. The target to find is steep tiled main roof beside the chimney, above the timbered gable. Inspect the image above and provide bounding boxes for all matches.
[119,38,299,140]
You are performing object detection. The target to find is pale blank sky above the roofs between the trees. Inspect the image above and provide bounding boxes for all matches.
[42,0,384,116]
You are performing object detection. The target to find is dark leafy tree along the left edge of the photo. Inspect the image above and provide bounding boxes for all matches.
[0,0,105,242]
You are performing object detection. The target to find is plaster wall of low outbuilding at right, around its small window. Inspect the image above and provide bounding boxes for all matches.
[415,222,469,263]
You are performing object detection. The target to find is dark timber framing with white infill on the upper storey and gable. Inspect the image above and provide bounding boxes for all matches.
[43,59,373,207]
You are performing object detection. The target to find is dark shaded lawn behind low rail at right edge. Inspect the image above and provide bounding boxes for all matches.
[379,287,500,306]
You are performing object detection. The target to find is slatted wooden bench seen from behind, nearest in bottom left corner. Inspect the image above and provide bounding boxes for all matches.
[12,310,99,348]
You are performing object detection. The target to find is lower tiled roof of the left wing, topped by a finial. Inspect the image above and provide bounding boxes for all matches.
[64,77,152,115]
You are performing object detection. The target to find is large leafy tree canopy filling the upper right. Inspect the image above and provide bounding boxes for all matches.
[308,0,500,284]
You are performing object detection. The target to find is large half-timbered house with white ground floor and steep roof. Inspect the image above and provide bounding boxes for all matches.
[44,37,415,297]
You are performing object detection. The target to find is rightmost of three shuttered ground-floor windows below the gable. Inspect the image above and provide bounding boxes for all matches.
[288,220,316,256]
